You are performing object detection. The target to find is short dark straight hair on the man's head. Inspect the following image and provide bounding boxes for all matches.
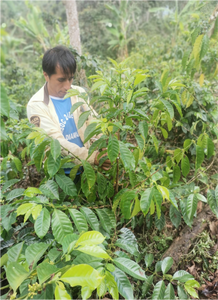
[42,46,76,77]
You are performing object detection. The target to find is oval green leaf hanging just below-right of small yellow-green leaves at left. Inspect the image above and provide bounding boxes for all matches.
[34,208,50,239]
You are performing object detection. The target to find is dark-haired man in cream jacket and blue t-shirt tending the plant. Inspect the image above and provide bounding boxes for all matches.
[27,46,110,170]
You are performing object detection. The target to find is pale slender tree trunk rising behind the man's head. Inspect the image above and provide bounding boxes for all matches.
[65,0,82,55]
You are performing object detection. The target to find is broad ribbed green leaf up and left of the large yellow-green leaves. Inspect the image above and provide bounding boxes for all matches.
[52,209,73,244]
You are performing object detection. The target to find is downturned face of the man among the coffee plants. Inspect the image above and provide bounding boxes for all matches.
[43,66,73,98]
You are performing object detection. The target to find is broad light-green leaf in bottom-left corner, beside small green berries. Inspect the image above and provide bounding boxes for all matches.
[6,262,29,291]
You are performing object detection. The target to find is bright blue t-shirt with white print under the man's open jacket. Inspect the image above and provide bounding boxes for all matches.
[50,96,83,174]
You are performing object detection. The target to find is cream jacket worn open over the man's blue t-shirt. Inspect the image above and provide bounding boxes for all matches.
[27,84,97,164]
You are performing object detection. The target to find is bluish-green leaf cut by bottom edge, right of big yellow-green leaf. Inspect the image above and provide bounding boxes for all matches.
[112,268,134,300]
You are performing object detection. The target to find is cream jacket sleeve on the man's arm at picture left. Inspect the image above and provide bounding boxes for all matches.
[27,102,97,164]
